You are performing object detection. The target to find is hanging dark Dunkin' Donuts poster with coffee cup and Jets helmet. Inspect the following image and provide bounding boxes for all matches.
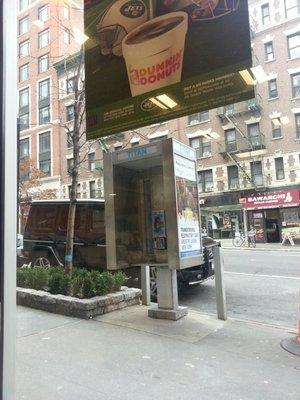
[84,0,254,139]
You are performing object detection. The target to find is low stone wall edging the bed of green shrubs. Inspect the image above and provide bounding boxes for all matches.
[17,286,142,319]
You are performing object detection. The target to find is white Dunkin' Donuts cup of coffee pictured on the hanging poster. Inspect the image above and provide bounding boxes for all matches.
[122,11,188,96]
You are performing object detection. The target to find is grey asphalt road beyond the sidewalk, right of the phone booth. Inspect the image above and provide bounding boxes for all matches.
[180,249,300,329]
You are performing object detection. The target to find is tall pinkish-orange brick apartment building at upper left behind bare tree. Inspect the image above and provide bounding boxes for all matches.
[18,0,83,198]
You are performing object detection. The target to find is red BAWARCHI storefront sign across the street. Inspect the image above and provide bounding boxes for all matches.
[240,189,300,210]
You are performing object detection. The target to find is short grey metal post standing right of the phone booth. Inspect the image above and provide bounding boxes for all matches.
[213,246,227,321]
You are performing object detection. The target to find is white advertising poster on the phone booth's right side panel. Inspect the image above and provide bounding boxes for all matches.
[174,155,201,258]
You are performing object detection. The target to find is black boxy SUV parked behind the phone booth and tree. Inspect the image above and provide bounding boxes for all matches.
[23,199,219,296]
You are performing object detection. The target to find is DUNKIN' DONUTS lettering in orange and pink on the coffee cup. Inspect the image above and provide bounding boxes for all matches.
[129,50,183,85]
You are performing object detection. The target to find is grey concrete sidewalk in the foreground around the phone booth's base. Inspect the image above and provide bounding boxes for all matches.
[16,306,300,400]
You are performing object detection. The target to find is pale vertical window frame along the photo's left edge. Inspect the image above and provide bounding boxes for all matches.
[0,0,17,400]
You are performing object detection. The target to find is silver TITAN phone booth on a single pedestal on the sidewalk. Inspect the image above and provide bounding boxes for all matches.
[104,139,203,320]
